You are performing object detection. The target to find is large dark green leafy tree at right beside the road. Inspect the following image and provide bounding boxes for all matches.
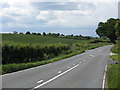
[96,18,120,43]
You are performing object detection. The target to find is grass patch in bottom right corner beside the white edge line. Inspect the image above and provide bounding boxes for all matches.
[107,64,120,90]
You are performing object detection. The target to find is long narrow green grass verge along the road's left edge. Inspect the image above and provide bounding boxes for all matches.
[1,43,109,74]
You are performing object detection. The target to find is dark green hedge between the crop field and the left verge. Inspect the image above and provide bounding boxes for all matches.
[2,45,69,64]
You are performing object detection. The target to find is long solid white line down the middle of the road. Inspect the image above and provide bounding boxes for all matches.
[32,64,79,90]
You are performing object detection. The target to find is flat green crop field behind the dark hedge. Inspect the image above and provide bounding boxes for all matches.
[2,34,83,46]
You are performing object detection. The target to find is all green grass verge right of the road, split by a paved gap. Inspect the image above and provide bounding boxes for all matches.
[107,44,120,90]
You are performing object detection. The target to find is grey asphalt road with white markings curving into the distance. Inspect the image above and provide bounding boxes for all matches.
[2,45,111,90]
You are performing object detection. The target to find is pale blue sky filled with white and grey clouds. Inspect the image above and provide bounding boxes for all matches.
[0,0,118,37]
